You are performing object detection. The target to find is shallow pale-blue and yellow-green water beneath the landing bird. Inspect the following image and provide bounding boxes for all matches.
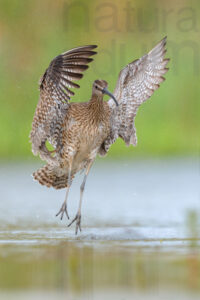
[0,159,200,300]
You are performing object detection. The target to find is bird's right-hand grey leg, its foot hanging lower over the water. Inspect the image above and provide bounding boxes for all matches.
[68,159,94,234]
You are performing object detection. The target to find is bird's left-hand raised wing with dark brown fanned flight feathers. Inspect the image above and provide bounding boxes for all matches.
[30,45,97,162]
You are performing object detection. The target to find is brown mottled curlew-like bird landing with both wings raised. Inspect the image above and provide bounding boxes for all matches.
[30,37,169,234]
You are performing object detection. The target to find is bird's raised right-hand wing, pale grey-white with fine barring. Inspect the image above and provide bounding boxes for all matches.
[105,37,169,154]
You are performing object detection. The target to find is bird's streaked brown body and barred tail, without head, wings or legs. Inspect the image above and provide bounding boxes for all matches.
[33,87,110,189]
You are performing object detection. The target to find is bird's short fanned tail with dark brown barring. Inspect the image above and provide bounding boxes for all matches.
[33,164,74,189]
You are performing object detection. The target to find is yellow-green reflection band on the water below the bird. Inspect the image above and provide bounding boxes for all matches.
[0,241,200,299]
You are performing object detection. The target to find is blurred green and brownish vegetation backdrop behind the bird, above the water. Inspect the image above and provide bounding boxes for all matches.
[0,0,200,160]
